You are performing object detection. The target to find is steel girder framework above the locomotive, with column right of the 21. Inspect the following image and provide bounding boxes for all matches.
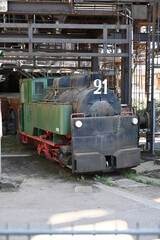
[0,1,138,106]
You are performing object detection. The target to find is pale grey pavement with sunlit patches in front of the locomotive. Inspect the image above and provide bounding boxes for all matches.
[0,177,160,239]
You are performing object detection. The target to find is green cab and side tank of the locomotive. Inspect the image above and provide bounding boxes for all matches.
[20,78,72,143]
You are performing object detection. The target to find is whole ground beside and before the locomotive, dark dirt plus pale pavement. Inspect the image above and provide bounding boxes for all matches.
[0,136,160,240]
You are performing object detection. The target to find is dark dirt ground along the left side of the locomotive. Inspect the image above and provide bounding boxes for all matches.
[2,134,76,182]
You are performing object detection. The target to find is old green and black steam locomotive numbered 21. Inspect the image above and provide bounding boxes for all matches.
[19,74,140,173]
